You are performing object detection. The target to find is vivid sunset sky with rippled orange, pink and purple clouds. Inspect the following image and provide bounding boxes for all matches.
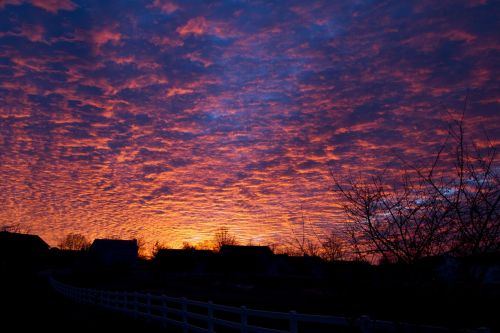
[0,0,500,246]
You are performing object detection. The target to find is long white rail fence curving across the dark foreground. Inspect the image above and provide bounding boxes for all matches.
[50,278,489,333]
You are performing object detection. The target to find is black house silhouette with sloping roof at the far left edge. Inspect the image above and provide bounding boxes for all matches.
[0,231,49,269]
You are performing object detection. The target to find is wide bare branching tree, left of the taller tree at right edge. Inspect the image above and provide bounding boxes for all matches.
[335,174,446,262]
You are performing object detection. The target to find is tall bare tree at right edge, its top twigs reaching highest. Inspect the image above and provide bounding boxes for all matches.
[416,107,500,255]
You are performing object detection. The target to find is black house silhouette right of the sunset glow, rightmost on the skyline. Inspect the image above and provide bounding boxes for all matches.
[217,245,277,275]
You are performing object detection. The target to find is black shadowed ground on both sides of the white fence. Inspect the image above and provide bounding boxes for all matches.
[0,270,500,333]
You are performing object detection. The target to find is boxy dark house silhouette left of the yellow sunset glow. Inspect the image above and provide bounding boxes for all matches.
[89,239,139,267]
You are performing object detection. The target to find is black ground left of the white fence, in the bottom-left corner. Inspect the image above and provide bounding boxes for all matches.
[0,272,167,333]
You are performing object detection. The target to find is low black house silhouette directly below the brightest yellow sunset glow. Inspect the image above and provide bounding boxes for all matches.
[153,249,215,274]
